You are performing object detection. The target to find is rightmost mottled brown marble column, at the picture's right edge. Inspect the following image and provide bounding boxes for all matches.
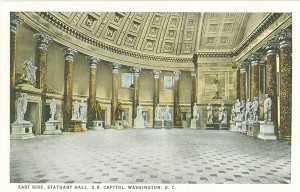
[276,29,292,140]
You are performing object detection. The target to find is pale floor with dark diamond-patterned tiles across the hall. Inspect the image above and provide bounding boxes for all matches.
[10,129,291,184]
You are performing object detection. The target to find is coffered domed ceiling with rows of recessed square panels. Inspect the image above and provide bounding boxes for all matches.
[21,12,268,70]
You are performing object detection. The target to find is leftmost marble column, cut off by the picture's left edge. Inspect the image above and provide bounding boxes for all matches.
[10,13,23,123]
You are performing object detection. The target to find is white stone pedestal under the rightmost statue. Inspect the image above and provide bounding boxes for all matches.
[257,121,277,140]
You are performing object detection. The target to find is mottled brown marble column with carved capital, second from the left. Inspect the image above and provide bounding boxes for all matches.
[33,33,52,134]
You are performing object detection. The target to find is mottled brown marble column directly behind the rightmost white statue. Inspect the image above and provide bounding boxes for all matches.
[262,39,278,134]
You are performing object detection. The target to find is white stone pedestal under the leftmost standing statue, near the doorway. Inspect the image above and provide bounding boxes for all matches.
[10,121,34,139]
